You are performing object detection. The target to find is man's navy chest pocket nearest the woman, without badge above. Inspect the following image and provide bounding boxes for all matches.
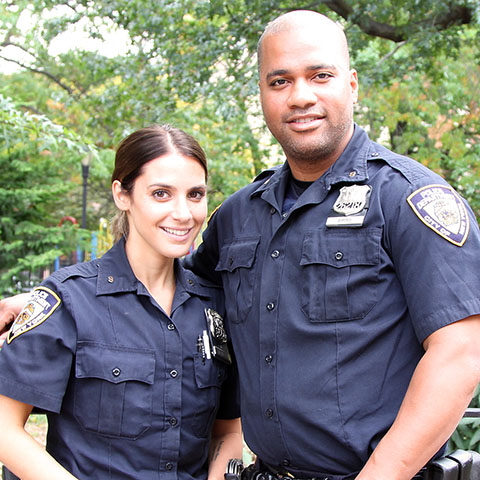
[215,236,260,323]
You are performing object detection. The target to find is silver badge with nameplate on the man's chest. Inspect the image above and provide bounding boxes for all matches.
[326,185,372,227]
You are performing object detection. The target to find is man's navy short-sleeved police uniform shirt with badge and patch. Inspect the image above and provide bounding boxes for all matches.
[188,126,480,477]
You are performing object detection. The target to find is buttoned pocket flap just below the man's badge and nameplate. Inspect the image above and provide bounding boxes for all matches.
[300,228,381,268]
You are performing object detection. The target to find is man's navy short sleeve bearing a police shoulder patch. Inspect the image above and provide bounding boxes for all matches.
[384,183,480,342]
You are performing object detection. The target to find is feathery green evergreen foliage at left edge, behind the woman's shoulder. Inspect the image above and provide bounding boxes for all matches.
[0,95,90,293]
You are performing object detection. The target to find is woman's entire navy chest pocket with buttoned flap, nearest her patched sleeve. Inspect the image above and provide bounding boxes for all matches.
[74,342,155,438]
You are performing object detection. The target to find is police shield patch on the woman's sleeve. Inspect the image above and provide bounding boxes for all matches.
[7,287,61,343]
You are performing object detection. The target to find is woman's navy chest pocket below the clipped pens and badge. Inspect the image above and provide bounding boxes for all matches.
[193,355,226,437]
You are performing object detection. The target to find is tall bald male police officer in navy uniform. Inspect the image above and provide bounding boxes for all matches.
[0,7,480,480]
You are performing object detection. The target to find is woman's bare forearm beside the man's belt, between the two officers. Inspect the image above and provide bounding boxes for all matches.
[208,418,243,480]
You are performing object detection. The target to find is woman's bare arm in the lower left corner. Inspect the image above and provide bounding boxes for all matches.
[0,395,75,480]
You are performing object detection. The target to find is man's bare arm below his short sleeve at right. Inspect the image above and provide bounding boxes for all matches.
[357,315,480,480]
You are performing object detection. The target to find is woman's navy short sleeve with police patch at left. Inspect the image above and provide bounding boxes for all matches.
[0,280,76,413]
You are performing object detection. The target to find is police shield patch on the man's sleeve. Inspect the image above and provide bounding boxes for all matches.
[407,185,470,247]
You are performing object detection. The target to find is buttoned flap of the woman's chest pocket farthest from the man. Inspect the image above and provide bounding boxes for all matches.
[75,342,155,385]
